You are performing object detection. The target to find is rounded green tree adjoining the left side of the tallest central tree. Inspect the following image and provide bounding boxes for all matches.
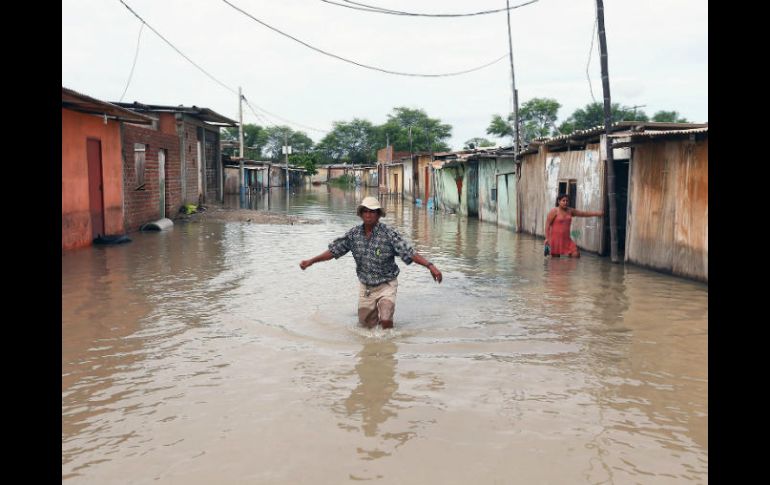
[316,118,377,164]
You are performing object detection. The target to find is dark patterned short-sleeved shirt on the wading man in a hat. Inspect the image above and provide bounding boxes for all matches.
[329,222,416,286]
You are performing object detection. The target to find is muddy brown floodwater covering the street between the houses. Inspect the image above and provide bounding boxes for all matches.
[62,186,708,484]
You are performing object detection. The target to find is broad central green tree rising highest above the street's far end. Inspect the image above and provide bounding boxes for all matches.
[375,106,452,152]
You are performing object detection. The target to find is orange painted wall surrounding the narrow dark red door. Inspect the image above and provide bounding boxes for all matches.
[62,108,124,249]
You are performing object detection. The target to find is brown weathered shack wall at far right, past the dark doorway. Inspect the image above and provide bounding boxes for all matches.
[626,140,708,281]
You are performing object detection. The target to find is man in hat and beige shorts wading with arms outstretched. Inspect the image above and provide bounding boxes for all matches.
[299,197,442,328]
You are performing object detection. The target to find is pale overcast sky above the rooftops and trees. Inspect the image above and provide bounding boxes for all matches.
[62,0,708,149]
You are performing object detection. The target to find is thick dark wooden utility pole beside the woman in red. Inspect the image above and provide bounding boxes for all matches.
[596,0,620,263]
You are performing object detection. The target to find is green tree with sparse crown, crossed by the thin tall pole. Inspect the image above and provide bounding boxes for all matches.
[487,98,561,144]
